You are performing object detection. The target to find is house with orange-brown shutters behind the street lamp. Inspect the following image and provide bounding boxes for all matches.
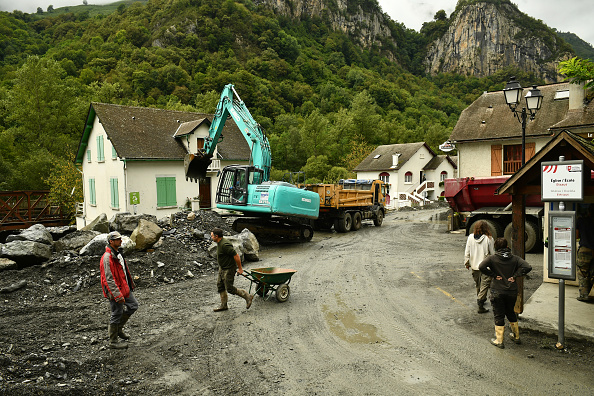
[450,83,584,177]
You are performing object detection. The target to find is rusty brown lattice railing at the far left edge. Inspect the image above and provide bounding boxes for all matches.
[0,190,70,230]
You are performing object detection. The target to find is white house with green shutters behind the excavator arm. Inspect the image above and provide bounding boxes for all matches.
[75,103,250,228]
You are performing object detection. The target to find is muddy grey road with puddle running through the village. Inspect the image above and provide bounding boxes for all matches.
[0,209,594,395]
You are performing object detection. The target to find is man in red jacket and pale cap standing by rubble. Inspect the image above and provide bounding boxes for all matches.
[100,231,138,349]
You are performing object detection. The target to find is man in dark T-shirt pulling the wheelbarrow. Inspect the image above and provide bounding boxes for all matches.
[210,228,254,312]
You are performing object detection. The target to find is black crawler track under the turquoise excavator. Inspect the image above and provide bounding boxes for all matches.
[233,217,314,242]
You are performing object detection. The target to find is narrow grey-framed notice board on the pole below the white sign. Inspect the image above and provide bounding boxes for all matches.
[549,211,576,280]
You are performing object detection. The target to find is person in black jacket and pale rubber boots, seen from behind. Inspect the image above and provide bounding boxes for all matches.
[479,238,532,348]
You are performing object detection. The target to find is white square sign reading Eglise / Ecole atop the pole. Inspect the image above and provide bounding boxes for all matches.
[541,160,584,202]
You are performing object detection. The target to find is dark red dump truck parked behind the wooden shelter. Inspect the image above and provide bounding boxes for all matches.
[444,176,544,252]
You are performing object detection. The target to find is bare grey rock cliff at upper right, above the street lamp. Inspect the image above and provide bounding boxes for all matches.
[425,3,571,83]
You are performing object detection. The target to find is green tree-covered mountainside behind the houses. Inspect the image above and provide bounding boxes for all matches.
[0,0,576,198]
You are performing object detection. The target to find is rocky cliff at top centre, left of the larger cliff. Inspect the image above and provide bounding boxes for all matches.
[254,0,396,51]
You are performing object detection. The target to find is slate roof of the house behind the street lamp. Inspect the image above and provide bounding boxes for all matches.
[450,82,569,142]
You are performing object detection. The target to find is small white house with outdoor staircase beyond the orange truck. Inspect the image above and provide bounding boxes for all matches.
[353,142,456,209]
